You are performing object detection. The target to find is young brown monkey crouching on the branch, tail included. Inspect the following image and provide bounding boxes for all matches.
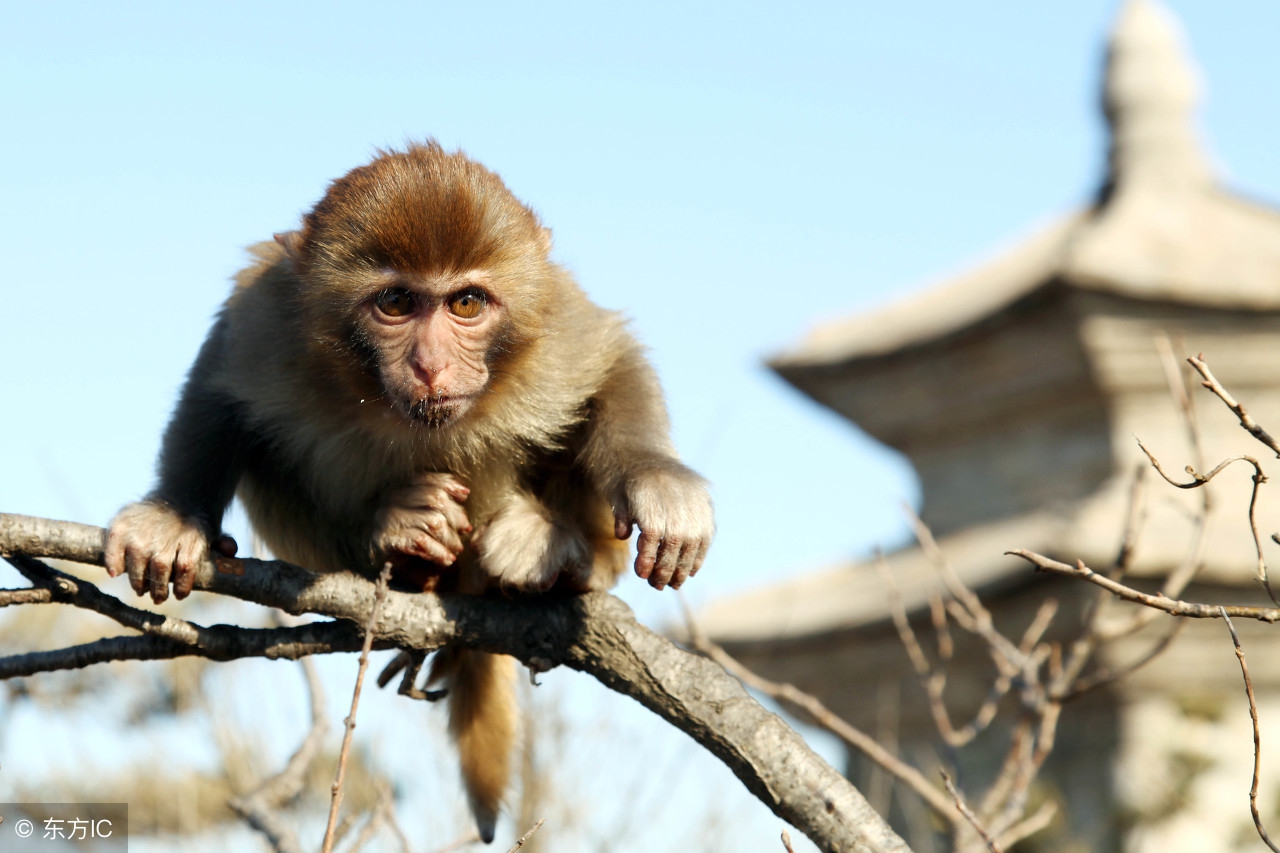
[105,140,714,841]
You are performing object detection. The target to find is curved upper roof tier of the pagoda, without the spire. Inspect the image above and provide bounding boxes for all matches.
[769,188,1280,384]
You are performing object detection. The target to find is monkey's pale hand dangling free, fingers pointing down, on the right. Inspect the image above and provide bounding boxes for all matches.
[613,461,716,589]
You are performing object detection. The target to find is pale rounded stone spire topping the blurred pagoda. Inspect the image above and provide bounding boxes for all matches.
[1102,0,1213,195]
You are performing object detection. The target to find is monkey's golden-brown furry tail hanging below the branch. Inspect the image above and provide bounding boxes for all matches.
[430,648,520,844]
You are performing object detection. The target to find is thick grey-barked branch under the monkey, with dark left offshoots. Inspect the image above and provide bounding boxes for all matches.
[0,514,909,853]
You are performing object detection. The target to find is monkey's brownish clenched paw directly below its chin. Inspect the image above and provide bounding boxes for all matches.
[371,473,471,566]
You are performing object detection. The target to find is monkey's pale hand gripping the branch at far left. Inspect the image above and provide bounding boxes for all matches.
[105,501,236,605]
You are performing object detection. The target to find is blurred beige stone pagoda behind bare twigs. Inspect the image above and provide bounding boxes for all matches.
[701,0,1280,853]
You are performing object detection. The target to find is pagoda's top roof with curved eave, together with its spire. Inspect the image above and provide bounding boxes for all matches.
[771,0,1280,375]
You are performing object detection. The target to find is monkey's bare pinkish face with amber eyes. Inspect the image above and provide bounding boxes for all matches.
[357,270,506,427]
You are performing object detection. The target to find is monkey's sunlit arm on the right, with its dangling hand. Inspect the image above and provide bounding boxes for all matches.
[579,343,716,589]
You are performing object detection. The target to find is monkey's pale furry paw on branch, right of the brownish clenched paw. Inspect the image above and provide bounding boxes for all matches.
[472,492,591,592]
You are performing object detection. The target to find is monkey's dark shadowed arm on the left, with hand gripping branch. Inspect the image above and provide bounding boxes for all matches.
[106,318,246,603]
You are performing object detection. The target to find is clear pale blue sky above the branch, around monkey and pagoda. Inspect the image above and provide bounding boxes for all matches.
[0,0,1280,845]
